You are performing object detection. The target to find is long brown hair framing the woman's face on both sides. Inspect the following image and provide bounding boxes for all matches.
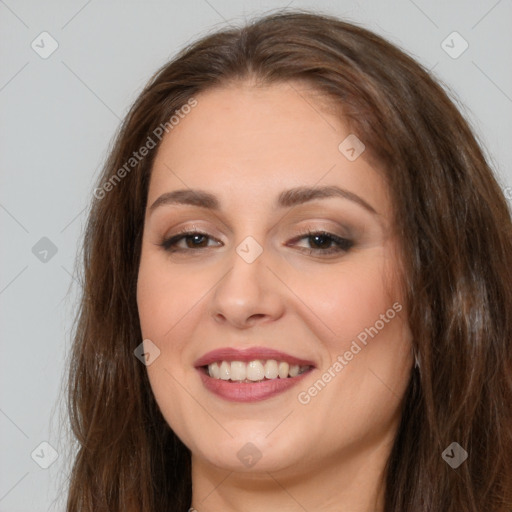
[67,10,512,512]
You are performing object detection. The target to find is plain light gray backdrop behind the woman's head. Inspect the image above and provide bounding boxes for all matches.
[0,0,512,512]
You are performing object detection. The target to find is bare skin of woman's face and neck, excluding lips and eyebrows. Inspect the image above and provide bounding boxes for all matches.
[137,81,413,512]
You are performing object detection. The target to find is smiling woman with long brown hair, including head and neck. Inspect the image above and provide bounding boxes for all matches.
[64,11,512,512]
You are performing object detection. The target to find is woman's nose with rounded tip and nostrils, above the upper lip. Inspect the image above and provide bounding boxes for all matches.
[210,245,287,329]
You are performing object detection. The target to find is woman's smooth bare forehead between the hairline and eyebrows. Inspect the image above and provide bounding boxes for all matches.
[148,82,389,218]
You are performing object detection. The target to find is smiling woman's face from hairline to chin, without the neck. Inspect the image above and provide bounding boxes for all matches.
[137,83,412,474]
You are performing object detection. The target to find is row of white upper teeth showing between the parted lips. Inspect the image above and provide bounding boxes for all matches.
[202,359,313,384]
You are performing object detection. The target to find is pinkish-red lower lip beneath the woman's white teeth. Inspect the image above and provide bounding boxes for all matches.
[198,368,311,402]
